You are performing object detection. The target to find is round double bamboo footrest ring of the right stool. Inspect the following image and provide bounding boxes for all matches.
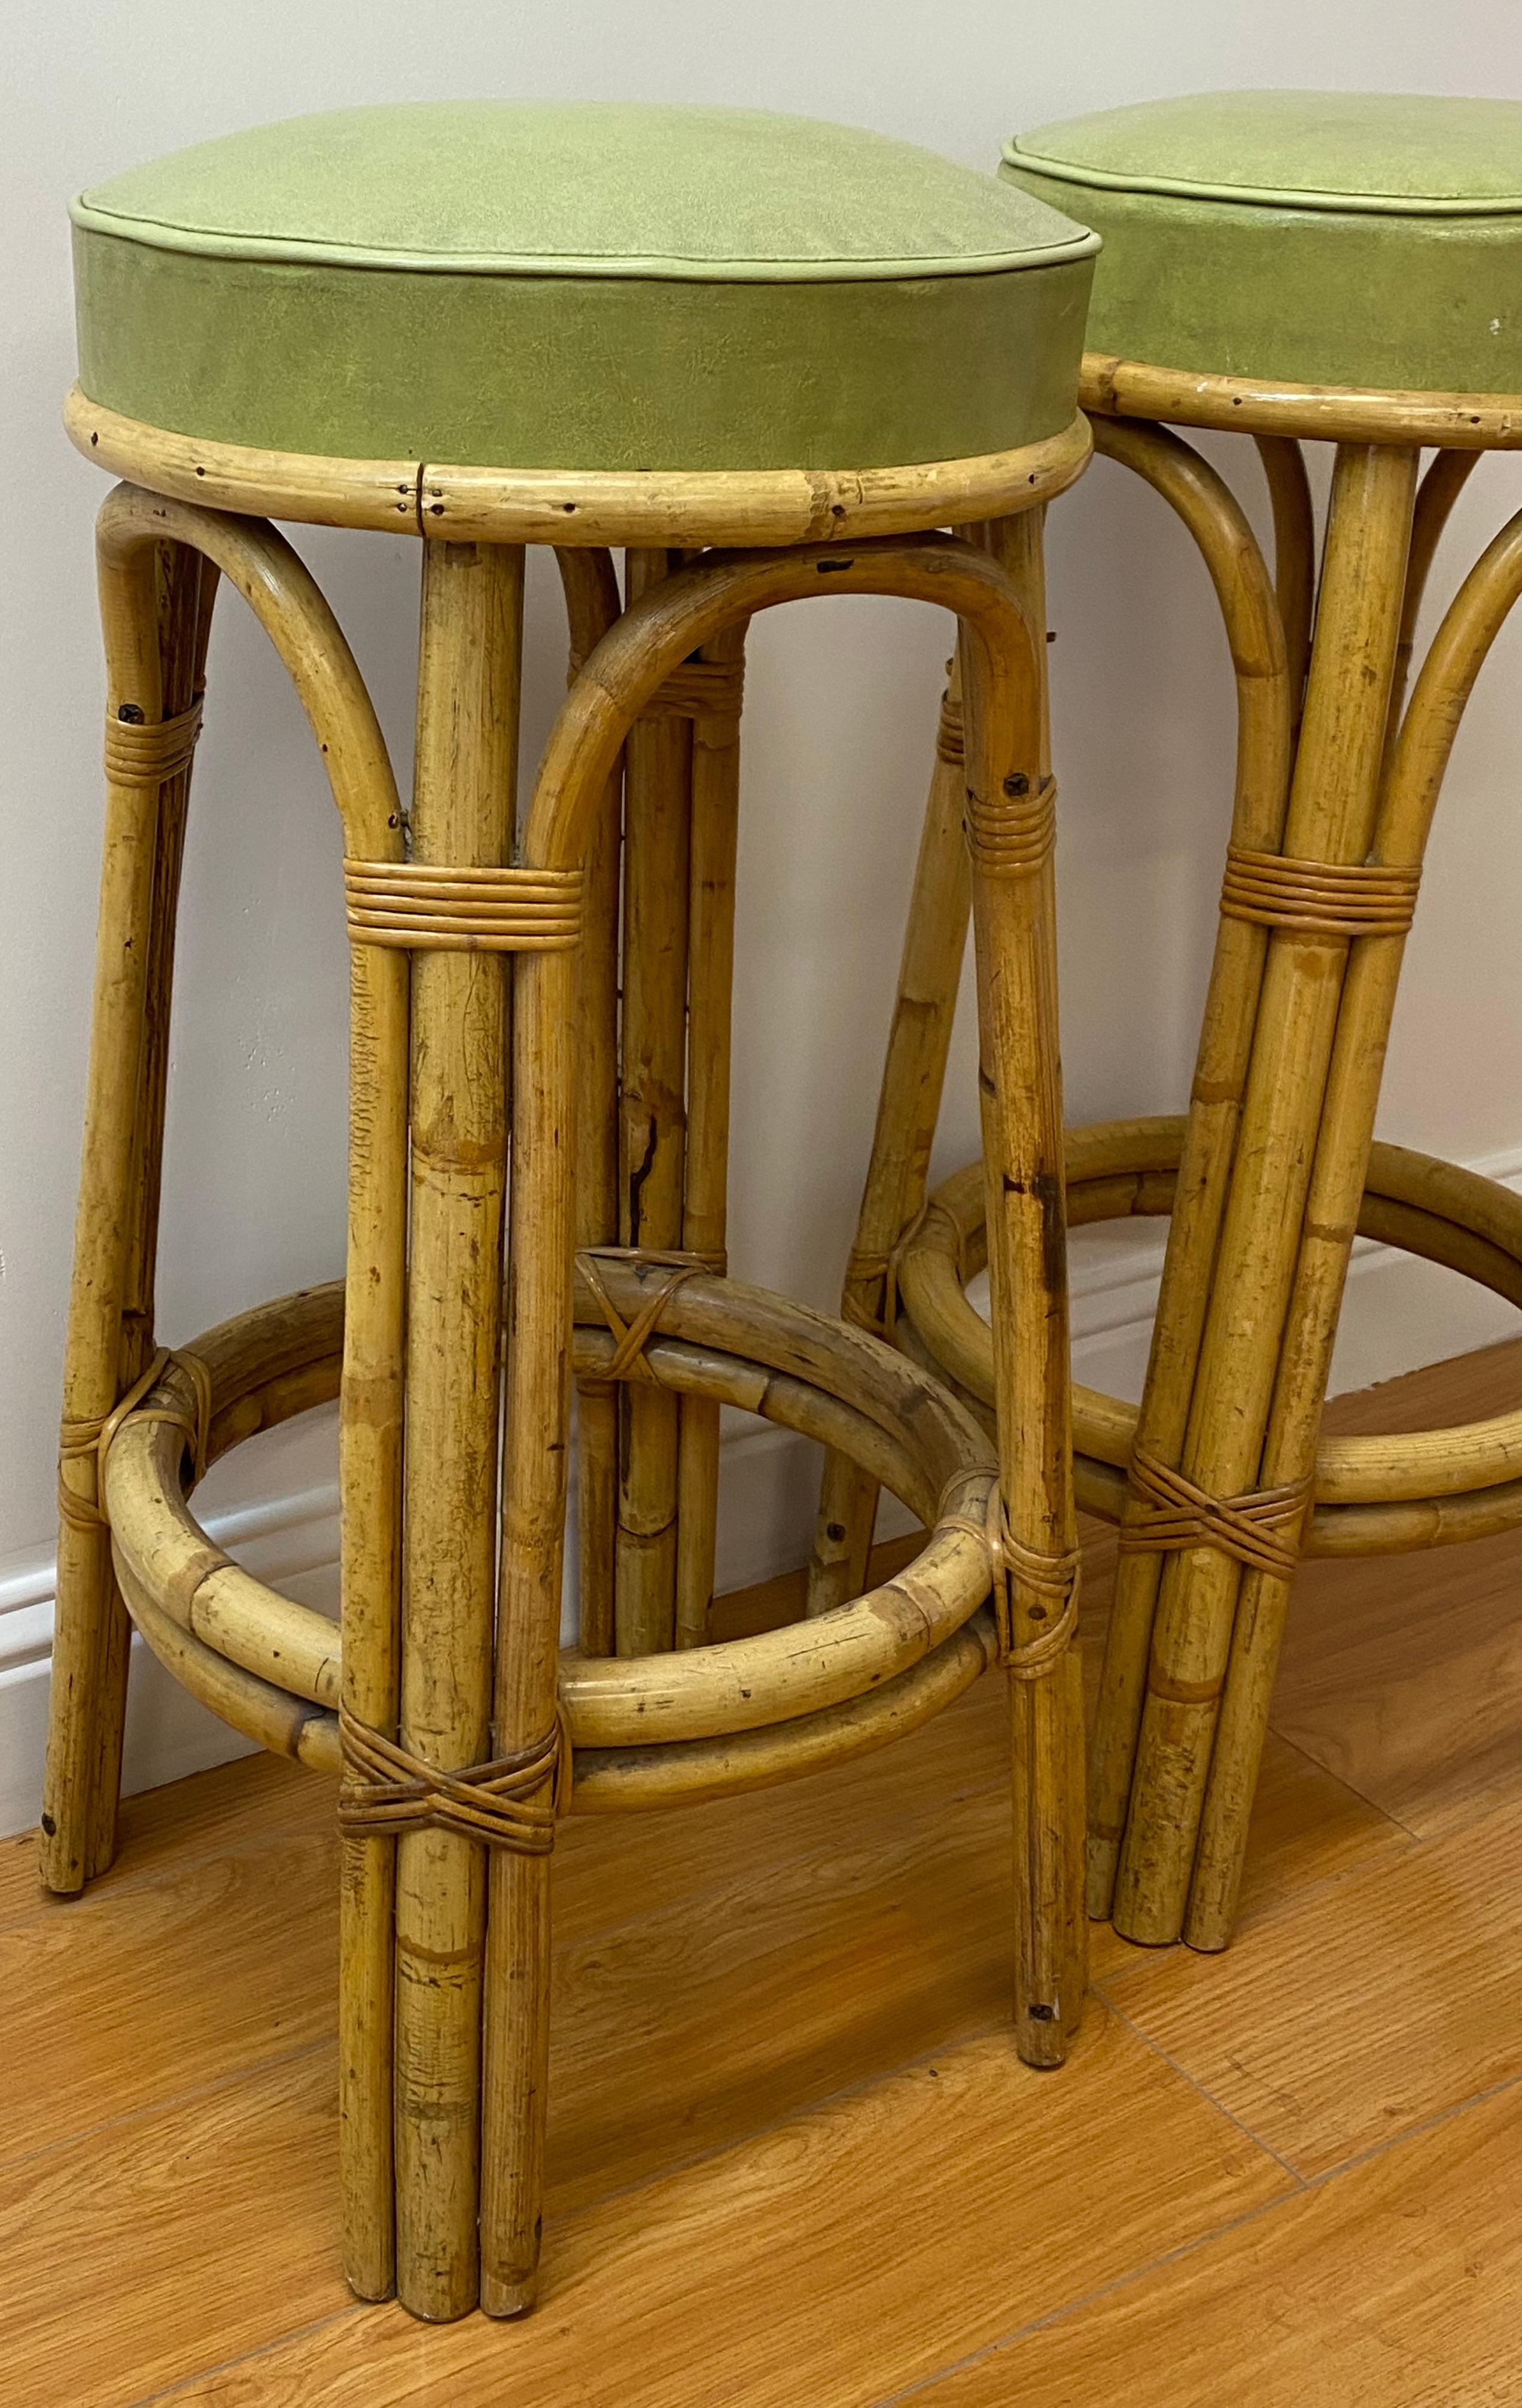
[896,1117,1522,1556]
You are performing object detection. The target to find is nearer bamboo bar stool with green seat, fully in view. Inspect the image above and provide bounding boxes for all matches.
[43,103,1096,2319]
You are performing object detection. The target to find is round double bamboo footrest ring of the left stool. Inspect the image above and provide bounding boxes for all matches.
[104,1255,997,1813]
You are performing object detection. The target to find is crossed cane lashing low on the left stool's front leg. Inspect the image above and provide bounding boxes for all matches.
[337,1705,573,1857]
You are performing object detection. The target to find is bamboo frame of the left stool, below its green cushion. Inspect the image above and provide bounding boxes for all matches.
[41,395,1088,2319]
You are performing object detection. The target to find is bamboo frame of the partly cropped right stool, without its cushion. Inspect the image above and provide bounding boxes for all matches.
[809,354,1522,1948]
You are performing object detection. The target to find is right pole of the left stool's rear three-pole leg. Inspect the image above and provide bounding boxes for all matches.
[674,611,744,1647]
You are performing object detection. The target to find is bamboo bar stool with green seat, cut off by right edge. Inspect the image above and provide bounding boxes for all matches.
[812,92,1522,1948]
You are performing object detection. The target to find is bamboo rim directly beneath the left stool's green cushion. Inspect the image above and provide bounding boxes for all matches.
[63,385,1093,549]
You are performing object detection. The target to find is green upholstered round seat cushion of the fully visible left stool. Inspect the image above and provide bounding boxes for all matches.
[72,101,1098,470]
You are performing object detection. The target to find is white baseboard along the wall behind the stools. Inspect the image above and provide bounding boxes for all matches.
[0,1151,1522,1835]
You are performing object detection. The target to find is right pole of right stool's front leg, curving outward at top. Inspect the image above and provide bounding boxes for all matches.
[1185,489,1522,1948]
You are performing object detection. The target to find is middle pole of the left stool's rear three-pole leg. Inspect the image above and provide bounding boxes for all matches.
[616,551,693,1654]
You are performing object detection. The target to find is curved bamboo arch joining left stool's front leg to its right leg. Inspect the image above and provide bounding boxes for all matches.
[479,522,1083,2314]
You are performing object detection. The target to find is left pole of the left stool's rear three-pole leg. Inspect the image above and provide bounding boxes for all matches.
[559,547,624,1654]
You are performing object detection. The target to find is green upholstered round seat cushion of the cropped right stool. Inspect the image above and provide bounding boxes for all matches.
[1002,92,1522,392]
